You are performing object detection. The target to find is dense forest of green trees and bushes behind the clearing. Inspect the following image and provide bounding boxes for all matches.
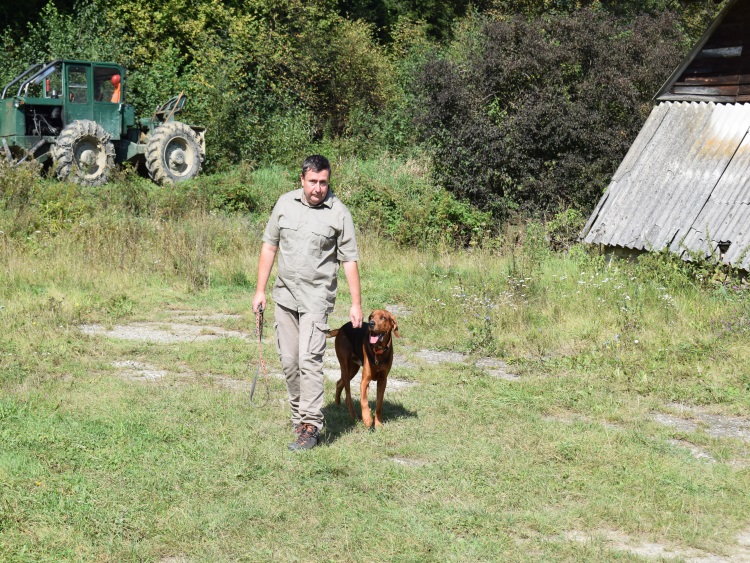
[0,0,722,229]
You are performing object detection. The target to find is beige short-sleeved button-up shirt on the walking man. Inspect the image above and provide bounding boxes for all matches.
[263,188,359,313]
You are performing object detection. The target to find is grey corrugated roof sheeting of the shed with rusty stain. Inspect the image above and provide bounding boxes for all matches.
[583,102,750,270]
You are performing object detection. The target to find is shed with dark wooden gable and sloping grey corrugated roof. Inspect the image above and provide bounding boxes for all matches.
[581,0,750,270]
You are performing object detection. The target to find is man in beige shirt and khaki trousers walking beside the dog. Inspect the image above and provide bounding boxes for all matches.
[253,155,362,451]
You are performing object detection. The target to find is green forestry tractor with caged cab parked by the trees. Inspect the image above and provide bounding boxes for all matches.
[0,60,206,186]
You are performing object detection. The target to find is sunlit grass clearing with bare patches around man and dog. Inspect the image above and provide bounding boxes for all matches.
[0,160,750,562]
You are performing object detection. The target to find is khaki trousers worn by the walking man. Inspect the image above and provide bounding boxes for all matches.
[274,304,328,429]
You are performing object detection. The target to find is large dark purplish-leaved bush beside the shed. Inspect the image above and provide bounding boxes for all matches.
[419,9,682,220]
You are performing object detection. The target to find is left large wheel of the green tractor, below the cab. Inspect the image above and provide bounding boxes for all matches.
[52,119,115,186]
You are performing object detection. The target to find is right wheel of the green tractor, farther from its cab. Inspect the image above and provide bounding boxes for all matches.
[146,121,203,184]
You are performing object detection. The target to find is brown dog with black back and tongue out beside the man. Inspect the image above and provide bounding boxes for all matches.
[328,309,400,428]
